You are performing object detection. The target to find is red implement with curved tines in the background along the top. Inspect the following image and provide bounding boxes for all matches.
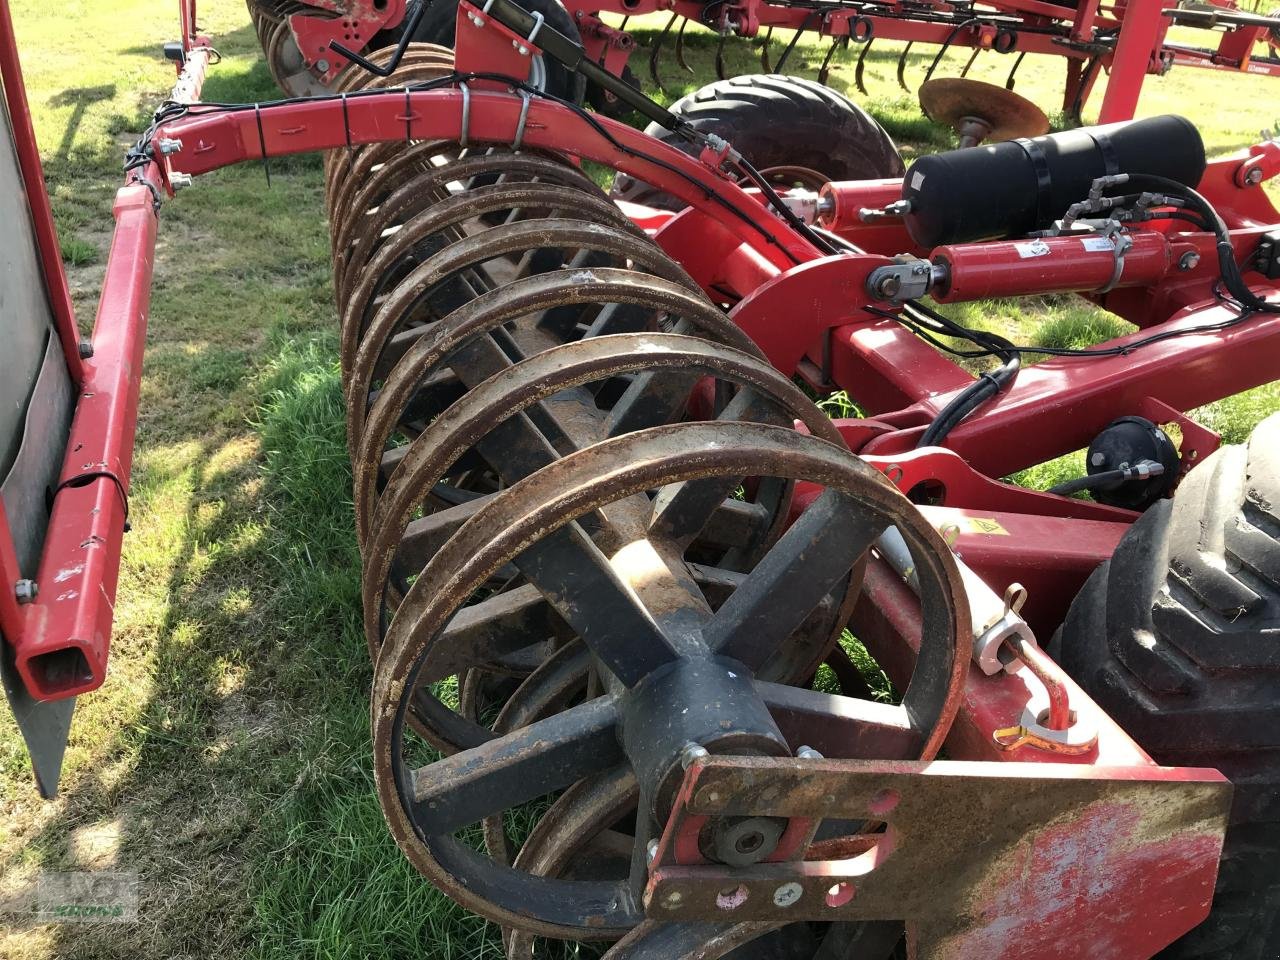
[247,0,1280,123]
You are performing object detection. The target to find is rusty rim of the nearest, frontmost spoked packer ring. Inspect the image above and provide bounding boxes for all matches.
[372,422,968,938]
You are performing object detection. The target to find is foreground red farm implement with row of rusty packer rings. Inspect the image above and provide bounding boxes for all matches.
[0,0,1280,960]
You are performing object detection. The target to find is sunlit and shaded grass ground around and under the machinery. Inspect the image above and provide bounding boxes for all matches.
[0,0,1280,960]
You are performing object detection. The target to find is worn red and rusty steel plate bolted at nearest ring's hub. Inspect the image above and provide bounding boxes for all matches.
[645,756,1231,960]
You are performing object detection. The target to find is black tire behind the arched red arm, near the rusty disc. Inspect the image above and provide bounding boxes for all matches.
[613,74,905,210]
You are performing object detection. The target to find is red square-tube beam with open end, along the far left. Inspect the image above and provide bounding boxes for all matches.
[0,28,207,700]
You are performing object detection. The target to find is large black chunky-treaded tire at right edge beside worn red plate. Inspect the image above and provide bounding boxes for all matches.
[1055,413,1280,960]
